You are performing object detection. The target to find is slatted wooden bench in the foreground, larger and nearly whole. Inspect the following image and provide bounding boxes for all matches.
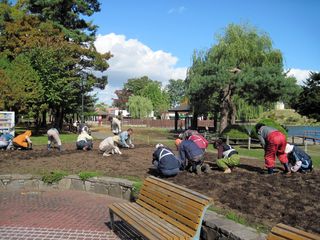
[109,177,212,239]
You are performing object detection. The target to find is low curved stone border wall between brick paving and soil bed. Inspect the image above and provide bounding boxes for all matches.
[0,174,266,240]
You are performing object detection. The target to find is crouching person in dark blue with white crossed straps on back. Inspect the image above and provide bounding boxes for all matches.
[152,143,181,177]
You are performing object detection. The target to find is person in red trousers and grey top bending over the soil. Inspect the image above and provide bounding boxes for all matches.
[255,123,290,174]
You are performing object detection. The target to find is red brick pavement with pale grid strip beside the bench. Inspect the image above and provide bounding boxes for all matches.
[0,190,135,240]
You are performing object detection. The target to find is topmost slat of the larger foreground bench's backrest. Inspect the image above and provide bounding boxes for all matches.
[146,177,212,205]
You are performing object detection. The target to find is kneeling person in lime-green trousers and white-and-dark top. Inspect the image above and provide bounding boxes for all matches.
[213,139,240,173]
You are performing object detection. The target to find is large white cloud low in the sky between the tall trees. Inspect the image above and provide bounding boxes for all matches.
[95,33,187,104]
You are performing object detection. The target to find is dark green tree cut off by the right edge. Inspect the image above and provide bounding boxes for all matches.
[293,72,320,121]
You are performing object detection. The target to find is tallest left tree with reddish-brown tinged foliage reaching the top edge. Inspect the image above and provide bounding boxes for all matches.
[0,0,111,127]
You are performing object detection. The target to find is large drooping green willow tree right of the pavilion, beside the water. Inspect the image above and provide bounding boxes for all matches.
[186,24,295,132]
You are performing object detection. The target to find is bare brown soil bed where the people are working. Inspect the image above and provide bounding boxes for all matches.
[0,142,320,234]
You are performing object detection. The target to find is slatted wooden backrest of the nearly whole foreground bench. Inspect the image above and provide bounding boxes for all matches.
[137,177,212,239]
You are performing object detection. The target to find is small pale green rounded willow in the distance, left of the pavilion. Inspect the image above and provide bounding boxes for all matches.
[128,96,153,119]
